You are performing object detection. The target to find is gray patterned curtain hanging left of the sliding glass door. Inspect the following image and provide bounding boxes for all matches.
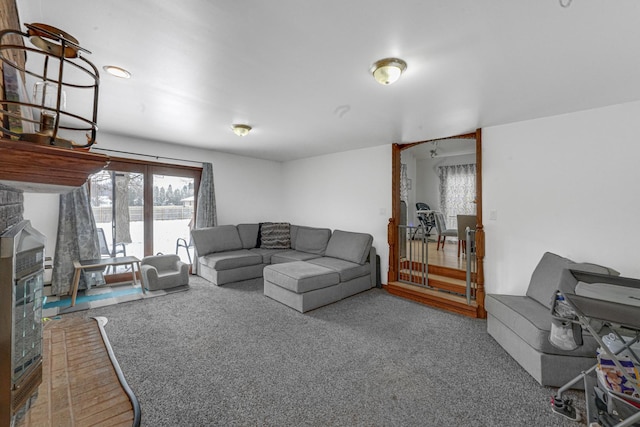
[51,183,100,295]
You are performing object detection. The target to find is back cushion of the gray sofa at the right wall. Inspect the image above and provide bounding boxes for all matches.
[527,252,619,309]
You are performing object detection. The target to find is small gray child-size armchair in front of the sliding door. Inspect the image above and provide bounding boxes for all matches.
[140,254,189,291]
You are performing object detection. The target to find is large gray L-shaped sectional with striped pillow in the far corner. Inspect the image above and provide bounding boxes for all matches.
[191,223,377,312]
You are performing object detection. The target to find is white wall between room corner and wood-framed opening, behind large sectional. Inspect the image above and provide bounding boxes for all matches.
[283,145,391,283]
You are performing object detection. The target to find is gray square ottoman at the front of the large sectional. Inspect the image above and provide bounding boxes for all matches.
[263,261,341,313]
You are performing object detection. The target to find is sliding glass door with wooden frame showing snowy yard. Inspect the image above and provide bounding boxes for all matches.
[90,159,201,272]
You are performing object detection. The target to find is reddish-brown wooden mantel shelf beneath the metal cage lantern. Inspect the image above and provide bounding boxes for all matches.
[0,139,109,191]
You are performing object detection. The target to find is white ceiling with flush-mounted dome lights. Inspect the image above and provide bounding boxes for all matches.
[12,0,640,161]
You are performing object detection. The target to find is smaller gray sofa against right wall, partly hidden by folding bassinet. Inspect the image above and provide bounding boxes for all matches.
[485,252,619,387]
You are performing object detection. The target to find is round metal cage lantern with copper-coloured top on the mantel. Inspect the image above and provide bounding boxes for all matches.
[0,23,100,149]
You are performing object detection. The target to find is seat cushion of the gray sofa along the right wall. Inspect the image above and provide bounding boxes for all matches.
[485,294,598,357]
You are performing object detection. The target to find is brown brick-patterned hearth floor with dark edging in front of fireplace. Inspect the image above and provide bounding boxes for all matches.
[16,316,140,427]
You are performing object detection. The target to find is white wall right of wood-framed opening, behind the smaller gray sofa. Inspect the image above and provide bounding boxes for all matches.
[482,102,640,294]
